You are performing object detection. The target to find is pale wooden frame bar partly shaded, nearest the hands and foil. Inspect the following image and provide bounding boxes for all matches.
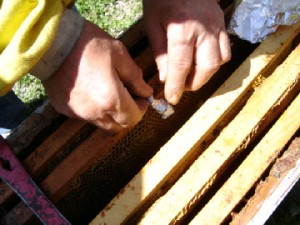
[91,23,300,225]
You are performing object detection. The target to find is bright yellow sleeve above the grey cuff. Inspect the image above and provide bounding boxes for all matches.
[0,0,73,95]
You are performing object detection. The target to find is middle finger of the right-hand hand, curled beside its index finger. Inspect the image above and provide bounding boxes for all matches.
[186,35,221,91]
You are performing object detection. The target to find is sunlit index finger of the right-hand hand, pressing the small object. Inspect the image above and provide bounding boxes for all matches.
[165,24,195,104]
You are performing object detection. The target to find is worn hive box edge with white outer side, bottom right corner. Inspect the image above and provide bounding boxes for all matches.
[230,137,300,225]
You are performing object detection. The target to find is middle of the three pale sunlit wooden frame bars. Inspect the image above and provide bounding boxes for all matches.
[140,41,300,224]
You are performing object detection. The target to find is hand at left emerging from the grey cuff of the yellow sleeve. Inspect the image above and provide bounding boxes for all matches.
[43,21,153,133]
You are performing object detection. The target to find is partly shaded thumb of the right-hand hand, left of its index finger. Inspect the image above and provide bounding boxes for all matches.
[145,20,168,81]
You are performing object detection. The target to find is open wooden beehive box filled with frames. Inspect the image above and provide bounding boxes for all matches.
[0,1,300,225]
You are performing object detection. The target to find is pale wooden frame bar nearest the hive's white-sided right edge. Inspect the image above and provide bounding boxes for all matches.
[190,92,300,225]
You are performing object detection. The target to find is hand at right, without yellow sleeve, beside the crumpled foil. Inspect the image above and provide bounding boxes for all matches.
[144,0,231,104]
